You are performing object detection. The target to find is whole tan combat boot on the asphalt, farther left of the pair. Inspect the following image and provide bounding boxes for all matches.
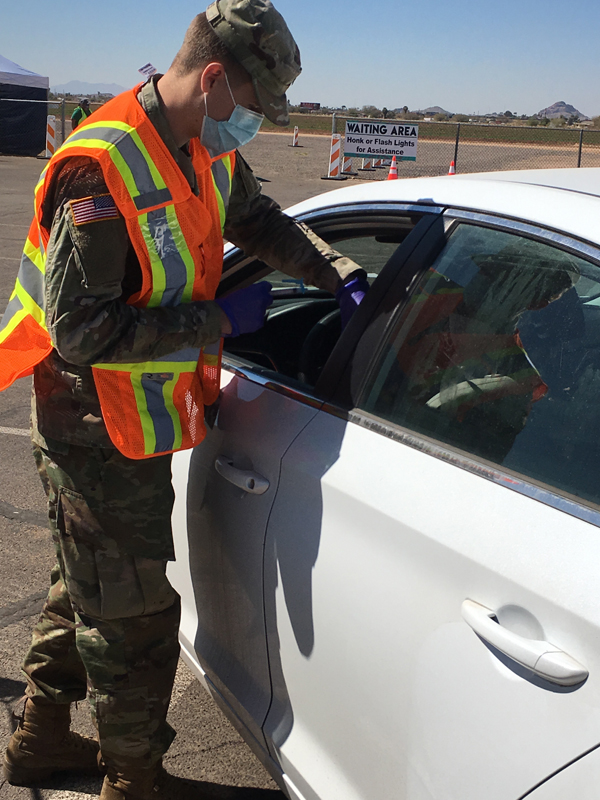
[4,697,100,786]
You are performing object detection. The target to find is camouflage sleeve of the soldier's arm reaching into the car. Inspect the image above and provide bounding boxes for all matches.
[225,153,366,293]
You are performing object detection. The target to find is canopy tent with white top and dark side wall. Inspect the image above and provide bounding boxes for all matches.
[0,55,50,156]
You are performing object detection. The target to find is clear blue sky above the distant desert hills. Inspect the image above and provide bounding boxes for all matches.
[0,0,600,116]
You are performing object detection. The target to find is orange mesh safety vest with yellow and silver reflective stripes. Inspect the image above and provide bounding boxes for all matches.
[0,86,235,459]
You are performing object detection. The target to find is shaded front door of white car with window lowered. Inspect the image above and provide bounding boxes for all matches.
[169,204,439,751]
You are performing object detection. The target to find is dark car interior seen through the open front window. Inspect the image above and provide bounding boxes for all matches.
[219,212,421,387]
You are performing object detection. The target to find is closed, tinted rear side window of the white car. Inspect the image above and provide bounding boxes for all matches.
[359,223,600,503]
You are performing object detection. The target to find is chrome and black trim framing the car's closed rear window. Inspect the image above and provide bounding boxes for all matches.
[332,208,600,528]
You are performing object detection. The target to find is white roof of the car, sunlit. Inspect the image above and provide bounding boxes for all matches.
[288,172,600,250]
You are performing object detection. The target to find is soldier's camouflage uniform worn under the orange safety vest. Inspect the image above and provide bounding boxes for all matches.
[23,17,358,767]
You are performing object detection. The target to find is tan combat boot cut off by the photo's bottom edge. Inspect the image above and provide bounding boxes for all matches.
[100,764,215,800]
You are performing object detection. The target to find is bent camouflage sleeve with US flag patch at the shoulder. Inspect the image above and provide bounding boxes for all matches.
[46,161,221,366]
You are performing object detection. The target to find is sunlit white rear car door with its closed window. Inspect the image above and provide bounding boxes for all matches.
[264,211,600,800]
